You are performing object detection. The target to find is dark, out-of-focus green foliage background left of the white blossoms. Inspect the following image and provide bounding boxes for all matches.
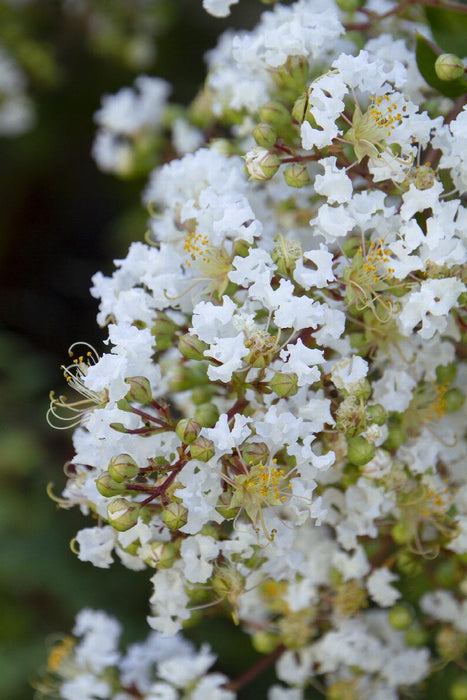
[0,0,274,700]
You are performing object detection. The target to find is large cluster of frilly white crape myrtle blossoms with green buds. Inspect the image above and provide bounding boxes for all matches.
[42,0,467,700]
